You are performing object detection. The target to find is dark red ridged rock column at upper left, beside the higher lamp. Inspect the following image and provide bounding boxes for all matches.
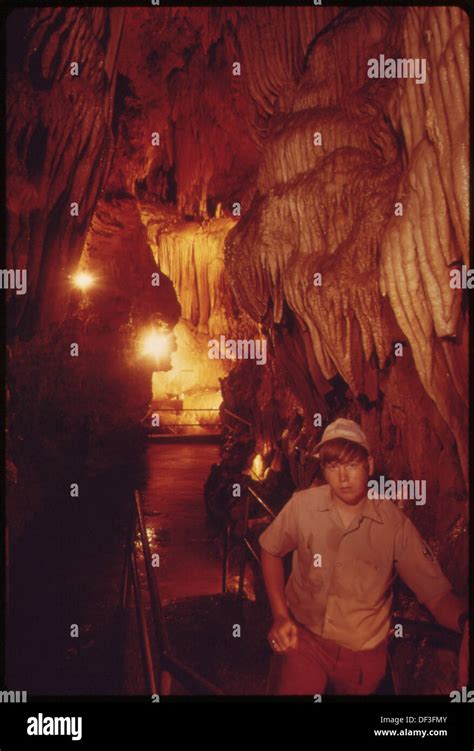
[7,8,124,336]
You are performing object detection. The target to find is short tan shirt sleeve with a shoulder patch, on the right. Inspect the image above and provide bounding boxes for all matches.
[395,516,452,605]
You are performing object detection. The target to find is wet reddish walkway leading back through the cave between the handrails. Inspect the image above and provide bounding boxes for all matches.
[124,442,268,694]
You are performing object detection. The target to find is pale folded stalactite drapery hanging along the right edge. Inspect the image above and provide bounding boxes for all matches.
[381,8,469,481]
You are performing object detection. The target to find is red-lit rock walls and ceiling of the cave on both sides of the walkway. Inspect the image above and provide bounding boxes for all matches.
[7,6,469,692]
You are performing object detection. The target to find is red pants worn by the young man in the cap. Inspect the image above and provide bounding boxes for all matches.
[267,623,387,696]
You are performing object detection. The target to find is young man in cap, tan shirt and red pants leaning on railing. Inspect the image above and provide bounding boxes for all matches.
[259,418,468,695]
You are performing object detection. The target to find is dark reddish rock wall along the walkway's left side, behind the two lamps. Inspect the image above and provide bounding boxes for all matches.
[7,8,180,541]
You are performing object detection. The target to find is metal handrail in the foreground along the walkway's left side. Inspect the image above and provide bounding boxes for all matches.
[121,490,224,695]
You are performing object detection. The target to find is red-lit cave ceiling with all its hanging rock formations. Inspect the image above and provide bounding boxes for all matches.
[7,6,469,494]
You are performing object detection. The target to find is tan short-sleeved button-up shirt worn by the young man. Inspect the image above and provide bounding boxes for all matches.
[259,485,451,650]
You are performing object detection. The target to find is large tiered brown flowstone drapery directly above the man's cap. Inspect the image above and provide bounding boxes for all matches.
[226,8,400,394]
